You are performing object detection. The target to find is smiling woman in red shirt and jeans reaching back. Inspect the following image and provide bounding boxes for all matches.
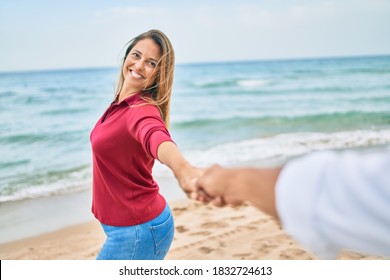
[90,30,200,260]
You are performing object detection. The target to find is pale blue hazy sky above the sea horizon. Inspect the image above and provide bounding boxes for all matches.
[0,0,390,72]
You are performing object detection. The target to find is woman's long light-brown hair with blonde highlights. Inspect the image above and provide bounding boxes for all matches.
[115,29,175,127]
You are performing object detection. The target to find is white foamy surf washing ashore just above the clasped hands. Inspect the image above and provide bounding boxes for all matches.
[182,130,390,166]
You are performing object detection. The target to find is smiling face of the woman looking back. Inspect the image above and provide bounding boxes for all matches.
[122,38,161,93]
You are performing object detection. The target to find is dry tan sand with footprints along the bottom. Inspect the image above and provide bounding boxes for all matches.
[0,199,382,260]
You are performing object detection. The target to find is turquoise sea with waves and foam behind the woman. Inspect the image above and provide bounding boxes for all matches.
[0,56,390,201]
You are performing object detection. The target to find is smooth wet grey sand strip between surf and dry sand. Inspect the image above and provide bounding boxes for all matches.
[0,176,186,244]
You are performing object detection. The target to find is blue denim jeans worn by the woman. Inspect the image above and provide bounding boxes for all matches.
[96,204,175,260]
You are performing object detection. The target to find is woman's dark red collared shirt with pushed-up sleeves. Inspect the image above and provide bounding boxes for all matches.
[90,93,173,226]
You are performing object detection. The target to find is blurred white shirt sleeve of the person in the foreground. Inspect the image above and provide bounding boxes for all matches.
[276,149,390,259]
